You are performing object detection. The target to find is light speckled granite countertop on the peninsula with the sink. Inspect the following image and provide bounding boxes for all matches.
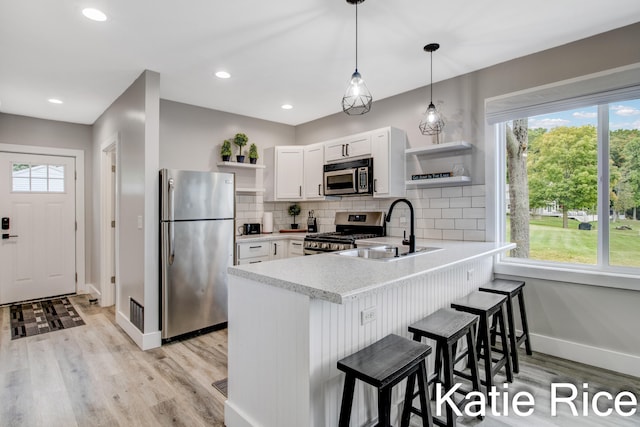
[229,237,515,304]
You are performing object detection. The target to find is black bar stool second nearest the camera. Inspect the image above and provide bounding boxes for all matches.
[409,308,480,427]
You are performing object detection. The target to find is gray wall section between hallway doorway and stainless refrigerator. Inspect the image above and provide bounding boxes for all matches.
[93,71,160,333]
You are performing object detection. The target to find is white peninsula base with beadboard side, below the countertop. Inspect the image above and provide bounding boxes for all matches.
[225,257,492,427]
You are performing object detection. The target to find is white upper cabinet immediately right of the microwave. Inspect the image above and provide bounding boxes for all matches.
[371,127,407,198]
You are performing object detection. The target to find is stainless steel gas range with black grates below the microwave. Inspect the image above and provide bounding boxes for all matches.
[304,212,386,255]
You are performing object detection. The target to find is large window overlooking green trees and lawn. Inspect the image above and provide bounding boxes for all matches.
[498,99,640,274]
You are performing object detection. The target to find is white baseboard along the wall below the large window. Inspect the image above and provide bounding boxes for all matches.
[530,334,640,377]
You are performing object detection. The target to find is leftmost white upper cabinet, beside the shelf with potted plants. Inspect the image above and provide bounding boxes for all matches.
[264,146,304,201]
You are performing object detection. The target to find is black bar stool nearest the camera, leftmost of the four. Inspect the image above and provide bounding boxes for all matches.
[338,334,433,427]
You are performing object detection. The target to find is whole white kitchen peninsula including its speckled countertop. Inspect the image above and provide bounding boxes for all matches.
[225,237,514,427]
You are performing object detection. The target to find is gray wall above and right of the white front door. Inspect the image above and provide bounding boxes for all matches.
[0,113,95,283]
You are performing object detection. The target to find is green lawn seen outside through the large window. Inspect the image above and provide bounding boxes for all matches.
[507,217,640,267]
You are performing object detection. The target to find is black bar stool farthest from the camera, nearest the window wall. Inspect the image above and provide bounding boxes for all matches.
[480,279,533,374]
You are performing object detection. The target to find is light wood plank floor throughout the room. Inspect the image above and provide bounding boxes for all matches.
[0,296,640,427]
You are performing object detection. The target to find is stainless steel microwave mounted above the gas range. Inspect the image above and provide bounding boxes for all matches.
[324,158,373,196]
